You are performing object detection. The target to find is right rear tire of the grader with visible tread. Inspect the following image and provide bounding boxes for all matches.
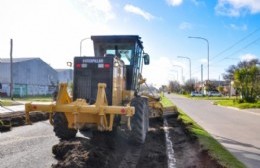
[130,97,149,144]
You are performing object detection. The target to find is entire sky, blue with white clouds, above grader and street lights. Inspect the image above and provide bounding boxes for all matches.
[0,0,260,86]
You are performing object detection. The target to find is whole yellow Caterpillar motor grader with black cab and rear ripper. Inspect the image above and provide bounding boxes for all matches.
[25,35,175,143]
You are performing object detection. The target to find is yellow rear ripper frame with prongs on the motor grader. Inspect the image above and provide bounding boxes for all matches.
[25,83,135,131]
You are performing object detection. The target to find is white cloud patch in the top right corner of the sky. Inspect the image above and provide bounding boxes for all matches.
[215,0,260,17]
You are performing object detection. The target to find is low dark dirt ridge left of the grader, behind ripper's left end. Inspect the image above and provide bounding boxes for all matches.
[0,112,49,132]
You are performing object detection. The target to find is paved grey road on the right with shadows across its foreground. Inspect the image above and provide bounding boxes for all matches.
[166,94,260,168]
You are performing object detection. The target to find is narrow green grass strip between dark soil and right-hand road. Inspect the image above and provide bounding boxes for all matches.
[178,109,246,168]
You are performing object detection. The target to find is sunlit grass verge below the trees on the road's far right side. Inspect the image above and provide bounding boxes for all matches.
[214,99,260,109]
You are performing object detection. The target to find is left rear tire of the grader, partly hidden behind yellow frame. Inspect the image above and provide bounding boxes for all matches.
[53,112,77,140]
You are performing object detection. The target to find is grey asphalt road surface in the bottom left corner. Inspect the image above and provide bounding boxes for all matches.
[0,121,59,168]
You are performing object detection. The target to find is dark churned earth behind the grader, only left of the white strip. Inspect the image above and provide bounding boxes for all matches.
[52,119,167,168]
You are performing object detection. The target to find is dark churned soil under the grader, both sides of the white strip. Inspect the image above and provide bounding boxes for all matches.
[52,117,221,168]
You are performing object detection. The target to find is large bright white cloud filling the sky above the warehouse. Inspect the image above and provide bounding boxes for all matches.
[0,0,116,68]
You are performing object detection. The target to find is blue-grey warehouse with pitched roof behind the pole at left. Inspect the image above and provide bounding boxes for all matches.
[0,58,58,97]
